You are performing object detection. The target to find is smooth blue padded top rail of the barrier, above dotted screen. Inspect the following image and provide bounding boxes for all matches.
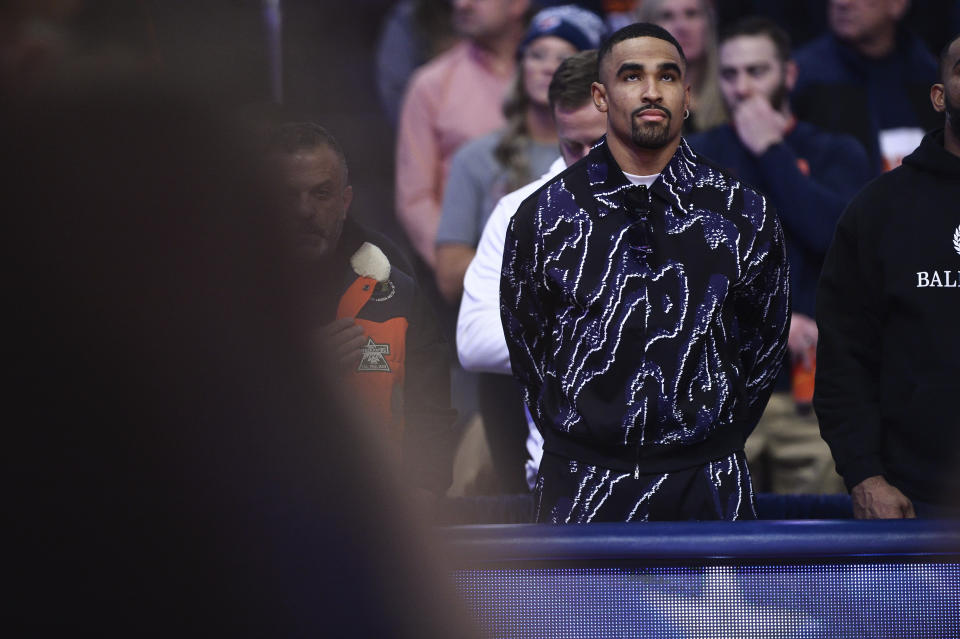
[444,519,960,562]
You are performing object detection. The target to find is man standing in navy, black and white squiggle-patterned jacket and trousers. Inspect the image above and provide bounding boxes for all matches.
[501,23,790,522]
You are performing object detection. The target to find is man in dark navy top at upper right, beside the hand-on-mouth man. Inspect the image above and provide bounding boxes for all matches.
[793,0,938,173]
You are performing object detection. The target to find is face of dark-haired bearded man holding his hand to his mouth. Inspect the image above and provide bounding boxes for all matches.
[719,35,796,111]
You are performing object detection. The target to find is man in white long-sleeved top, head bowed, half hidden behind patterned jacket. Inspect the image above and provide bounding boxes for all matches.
[457,50,607,488]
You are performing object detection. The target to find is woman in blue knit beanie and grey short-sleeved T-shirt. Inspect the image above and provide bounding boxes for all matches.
[436,5,604,304]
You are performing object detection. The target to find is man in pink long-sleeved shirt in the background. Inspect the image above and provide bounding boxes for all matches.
[396,0,530,269]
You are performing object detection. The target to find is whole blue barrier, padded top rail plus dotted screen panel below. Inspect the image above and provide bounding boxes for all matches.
[441,519,960,639]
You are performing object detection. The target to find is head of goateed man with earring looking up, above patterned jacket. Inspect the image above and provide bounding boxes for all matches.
[593,37,690,149]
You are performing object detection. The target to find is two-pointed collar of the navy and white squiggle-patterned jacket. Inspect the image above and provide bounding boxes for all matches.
[586,137,697,216]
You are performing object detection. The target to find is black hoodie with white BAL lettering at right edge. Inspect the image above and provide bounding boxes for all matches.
[814,129,960,505]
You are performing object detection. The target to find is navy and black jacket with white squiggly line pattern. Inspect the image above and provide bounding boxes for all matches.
[500,140,790,472]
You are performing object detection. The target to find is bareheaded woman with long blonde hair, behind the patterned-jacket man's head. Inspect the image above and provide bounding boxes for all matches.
[637,0,726,133]
